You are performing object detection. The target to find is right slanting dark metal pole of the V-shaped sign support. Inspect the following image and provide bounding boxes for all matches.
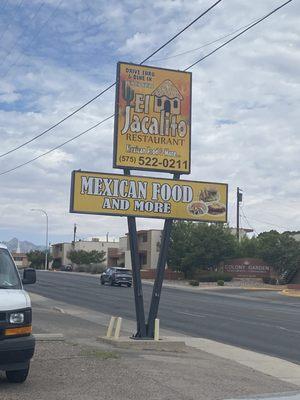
[147,174,180,338]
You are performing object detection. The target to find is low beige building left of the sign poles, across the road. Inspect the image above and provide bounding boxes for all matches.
[51,238,119,266]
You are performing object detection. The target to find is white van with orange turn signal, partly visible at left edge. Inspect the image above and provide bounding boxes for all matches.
[0,243,36,382]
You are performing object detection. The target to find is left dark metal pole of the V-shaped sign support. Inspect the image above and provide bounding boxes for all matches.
[124,169,147,338]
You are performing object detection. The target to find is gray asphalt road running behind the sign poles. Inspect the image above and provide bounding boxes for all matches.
[27,271,300,364]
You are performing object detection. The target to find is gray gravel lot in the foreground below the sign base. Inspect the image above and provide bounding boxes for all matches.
[0,342,297,400]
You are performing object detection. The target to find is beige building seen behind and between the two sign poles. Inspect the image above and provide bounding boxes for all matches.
[119,229,162,269]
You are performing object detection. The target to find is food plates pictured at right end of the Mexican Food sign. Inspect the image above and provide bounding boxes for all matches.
[187,187,226,216]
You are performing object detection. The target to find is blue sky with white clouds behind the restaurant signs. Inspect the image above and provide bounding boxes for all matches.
[0,0,300,244]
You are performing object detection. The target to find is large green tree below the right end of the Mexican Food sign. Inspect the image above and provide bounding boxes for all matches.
[168,222,237,277]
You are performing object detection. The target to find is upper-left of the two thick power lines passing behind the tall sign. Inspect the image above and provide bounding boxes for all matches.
[0,0,222,158]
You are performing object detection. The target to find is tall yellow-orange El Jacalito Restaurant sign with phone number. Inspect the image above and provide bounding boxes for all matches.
[113,63,192,174]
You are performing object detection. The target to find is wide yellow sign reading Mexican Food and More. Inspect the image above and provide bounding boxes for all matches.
[70,171,228,222]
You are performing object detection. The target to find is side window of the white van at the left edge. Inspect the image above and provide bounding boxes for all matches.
[0,249,21,289]
